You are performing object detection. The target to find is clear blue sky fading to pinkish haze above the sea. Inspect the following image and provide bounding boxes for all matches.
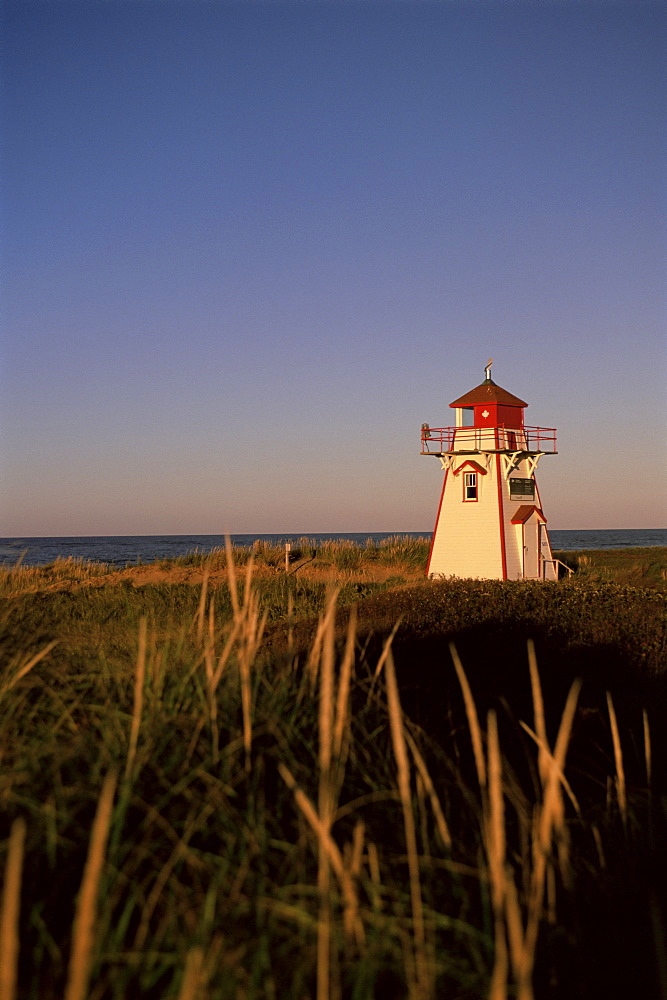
[0,0,667,536]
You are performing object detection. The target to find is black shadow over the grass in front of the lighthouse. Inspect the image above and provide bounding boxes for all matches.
[358,619,667,1000]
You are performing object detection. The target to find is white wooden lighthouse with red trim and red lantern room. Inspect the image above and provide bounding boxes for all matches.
[421,360,558,580]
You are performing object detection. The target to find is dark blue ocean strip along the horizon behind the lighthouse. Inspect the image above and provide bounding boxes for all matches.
[0,528,667,566]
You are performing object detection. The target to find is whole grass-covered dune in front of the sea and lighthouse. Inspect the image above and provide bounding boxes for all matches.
[0,538,667,1000]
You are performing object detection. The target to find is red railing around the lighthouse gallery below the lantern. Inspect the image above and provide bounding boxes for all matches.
[421,425,556,455]
